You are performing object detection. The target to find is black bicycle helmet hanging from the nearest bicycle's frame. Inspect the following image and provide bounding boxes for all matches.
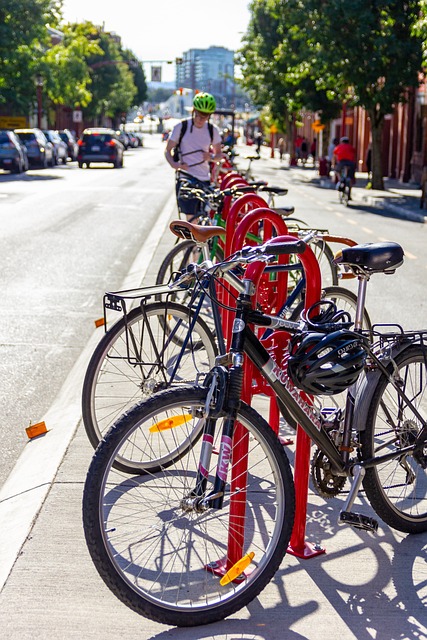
[288,329,366,396]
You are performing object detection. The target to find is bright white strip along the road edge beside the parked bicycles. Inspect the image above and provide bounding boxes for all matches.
[0,189,176,592]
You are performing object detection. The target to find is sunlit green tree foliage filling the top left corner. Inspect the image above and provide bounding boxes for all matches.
[0,0,62,114]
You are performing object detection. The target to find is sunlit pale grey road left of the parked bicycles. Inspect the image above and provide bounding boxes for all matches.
[0,135,174,486]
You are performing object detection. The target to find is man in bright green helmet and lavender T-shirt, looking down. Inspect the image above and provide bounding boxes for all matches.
[165,93,223,217]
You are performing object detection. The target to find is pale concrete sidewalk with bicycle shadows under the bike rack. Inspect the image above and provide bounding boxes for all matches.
[0,170,427,640]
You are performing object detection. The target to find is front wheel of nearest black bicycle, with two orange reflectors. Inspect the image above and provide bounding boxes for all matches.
[83,387,295,626]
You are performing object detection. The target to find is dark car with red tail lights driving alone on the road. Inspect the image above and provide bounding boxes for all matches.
[77,127,124,168]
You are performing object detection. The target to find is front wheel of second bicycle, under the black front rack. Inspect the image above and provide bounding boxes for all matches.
[82,302,218,468]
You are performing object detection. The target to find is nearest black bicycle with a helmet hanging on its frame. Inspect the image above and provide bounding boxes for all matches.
[83,237,427,626]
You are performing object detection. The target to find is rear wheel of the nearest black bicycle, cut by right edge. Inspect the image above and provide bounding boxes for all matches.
[360,345,427,533]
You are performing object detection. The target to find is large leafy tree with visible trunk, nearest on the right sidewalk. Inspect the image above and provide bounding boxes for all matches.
[299,0,426,189]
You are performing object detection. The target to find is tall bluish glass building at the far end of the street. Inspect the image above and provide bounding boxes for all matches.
[176,47,235,109]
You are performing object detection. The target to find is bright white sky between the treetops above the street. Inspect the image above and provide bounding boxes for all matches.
[63,0,250,80]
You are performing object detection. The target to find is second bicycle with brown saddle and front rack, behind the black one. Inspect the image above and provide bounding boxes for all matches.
[82,220,372,458]
